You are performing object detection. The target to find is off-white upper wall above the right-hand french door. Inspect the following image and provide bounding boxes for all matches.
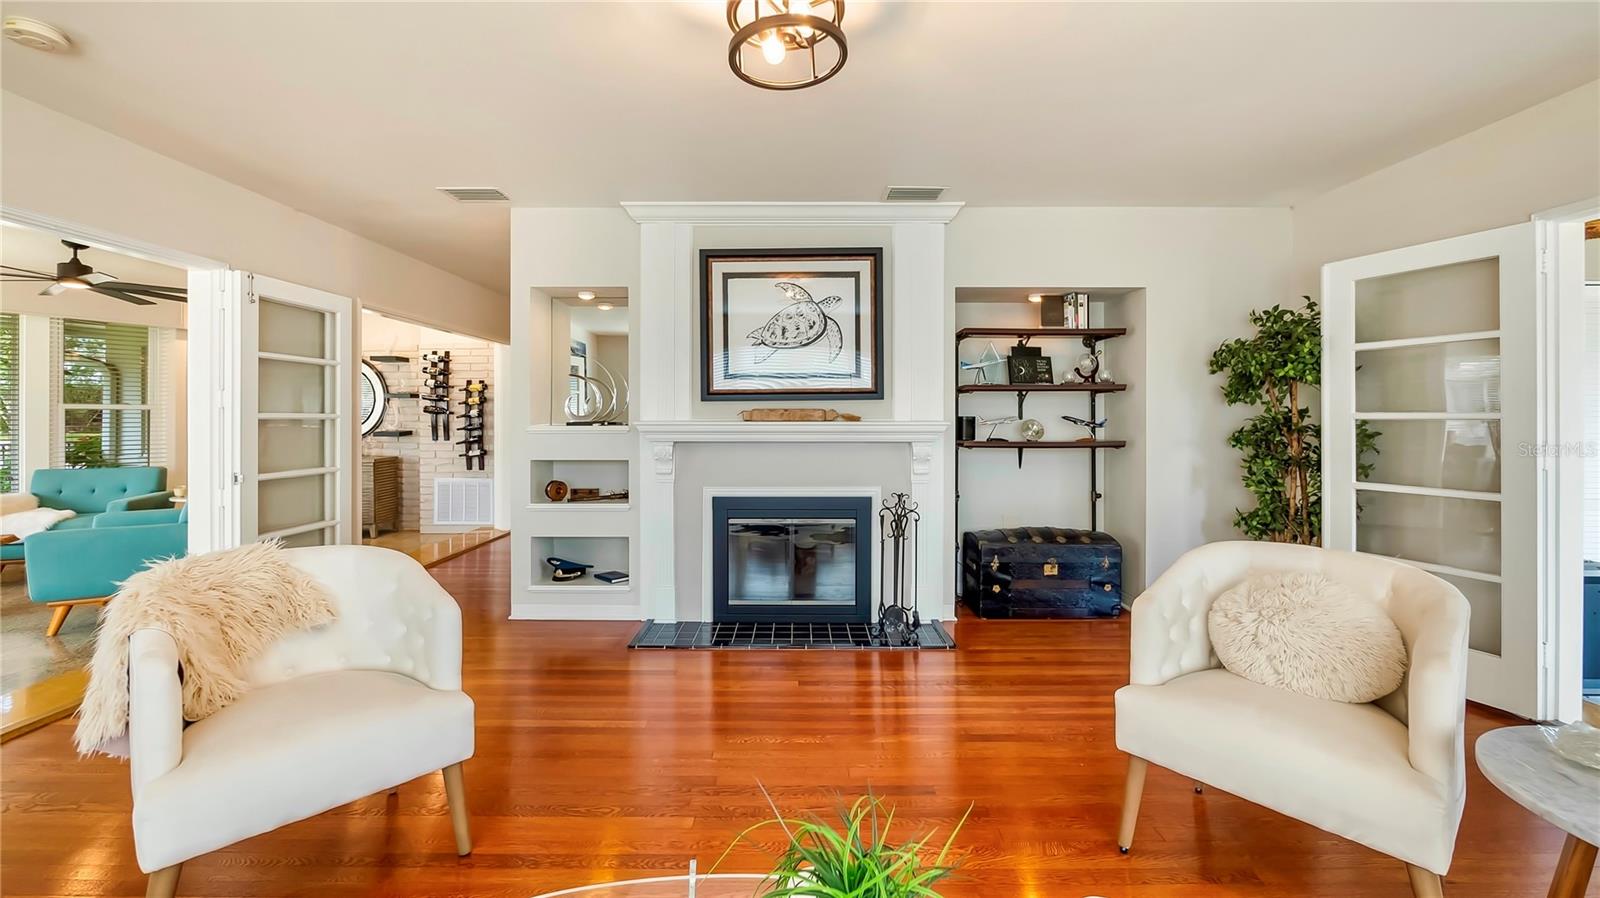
[1293,82,1600,296]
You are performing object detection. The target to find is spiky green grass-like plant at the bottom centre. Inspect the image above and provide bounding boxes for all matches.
[712,788,973,898]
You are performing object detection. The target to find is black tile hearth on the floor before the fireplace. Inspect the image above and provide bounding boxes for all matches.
[627,619,955,651]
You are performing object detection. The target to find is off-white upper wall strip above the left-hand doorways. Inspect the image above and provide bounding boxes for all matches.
[0,93,507,343]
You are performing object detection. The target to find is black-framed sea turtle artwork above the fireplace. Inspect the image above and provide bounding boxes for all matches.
[699,247,883,400]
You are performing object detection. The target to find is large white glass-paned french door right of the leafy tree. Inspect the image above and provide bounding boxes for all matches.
[1322,224,1544,717]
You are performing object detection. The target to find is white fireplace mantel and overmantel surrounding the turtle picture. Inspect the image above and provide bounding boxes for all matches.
[622,202,962,621]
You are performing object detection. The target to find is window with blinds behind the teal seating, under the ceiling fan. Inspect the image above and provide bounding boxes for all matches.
[51,319,166,467]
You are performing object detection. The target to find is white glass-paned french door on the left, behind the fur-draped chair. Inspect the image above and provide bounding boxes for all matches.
[229,272,355,546]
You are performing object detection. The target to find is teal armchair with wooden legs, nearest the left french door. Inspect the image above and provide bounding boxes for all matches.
[22,509,189,635]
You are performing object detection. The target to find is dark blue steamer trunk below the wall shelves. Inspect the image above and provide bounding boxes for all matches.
[962,527,1122,618]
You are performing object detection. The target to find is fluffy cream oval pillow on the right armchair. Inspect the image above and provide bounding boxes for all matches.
[1206,573,1406,703]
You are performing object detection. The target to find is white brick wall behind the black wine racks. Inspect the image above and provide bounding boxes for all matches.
[362,343,498,531]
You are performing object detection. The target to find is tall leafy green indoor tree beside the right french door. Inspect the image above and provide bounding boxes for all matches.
[1210,296,1381,546]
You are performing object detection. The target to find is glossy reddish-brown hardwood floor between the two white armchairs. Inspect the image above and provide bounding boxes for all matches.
[0,541,1574,898]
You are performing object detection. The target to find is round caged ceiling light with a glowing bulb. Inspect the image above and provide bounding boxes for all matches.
[728,0,850,90]
